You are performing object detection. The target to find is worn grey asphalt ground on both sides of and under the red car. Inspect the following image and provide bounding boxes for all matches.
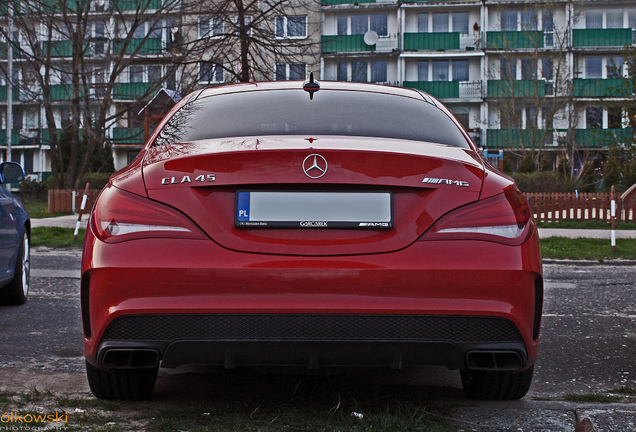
[0,248,636,431]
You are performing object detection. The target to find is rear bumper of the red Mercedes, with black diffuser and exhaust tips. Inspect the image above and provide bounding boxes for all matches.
[82,228,543,370]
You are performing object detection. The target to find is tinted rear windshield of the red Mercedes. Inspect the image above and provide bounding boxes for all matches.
[155,89,469,148]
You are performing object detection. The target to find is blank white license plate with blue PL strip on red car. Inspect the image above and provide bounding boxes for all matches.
[235,191,393,229]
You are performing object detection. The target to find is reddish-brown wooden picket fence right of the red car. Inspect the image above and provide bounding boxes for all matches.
[523,193,636,222]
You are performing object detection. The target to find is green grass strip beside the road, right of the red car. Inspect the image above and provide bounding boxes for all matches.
[541,237,636,261]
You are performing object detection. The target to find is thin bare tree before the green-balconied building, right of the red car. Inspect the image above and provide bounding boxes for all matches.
[487,3,573,173]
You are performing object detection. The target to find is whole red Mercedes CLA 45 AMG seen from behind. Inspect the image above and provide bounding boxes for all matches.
[81,79,543,399]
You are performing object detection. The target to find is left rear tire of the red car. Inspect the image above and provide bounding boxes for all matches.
[86,362,159,401]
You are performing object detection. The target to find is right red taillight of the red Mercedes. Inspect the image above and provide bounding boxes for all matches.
[422,187,531,244]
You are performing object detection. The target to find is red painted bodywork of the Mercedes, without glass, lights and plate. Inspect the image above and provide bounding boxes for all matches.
[82,84,542,372]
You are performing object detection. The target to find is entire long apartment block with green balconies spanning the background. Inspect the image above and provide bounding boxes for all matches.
[0,0,636,178]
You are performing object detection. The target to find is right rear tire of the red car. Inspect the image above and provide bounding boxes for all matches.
[461,366,534,400]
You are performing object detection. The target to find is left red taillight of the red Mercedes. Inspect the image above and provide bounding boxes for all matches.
[91,186,205,243]
